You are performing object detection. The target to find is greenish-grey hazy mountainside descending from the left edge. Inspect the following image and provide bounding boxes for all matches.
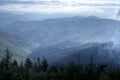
[0,31,36,60]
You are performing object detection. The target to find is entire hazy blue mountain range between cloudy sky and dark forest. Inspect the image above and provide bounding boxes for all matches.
[0,14,120,64]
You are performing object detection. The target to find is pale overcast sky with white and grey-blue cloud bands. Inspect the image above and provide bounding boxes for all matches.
[0,0,120,17]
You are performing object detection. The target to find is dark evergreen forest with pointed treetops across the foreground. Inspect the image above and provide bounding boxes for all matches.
[0,49,120,80]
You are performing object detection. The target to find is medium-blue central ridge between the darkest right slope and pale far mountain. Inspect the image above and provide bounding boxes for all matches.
[29,41,82,63]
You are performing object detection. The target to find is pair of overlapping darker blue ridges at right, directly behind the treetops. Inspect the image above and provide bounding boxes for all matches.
[30,42,120,65]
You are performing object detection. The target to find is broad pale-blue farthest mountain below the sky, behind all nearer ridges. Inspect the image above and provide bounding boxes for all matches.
[1,16,120,47]
